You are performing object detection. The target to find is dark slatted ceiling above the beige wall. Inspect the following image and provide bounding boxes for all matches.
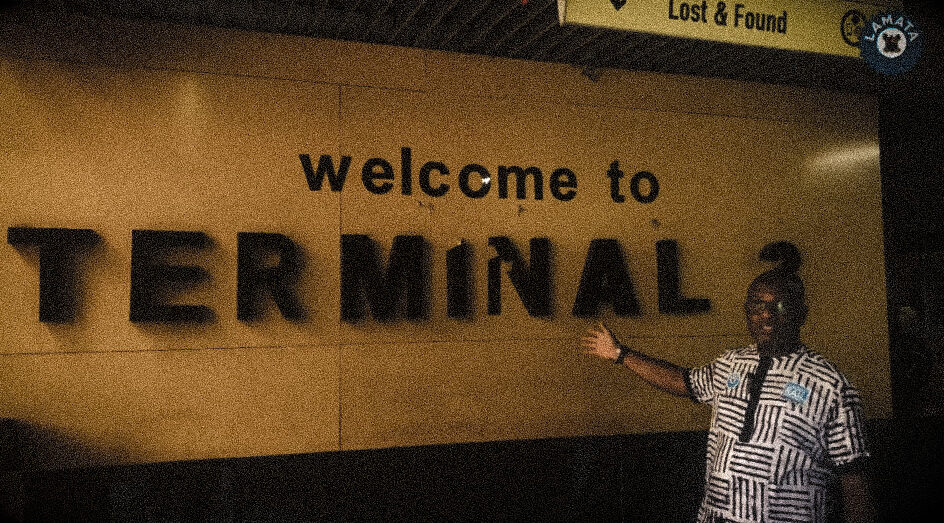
[9,0,892,92]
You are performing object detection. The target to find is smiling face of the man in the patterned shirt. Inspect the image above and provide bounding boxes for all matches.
[744,283,806,354]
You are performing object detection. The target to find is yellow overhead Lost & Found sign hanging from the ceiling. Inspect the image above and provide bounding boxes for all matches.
[557,0,889,57]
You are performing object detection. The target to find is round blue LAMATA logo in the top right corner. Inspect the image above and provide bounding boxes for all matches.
[859,12,924,75]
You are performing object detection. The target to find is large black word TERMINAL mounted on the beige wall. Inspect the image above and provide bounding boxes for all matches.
[7,227,732,323]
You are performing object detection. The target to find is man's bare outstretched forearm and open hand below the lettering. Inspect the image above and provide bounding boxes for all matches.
[580,323,689,397]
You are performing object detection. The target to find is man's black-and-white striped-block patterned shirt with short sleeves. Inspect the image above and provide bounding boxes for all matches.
[684,345,869,523]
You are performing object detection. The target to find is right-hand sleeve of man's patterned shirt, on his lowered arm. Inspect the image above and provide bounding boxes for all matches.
[825,383,870,472]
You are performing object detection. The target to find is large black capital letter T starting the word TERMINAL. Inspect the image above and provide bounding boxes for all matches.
[7,227,99,323]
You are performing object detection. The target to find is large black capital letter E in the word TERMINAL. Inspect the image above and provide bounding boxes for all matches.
[129,230,214,323]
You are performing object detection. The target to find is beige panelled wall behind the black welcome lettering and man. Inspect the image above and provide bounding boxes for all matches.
[0,14,891,467]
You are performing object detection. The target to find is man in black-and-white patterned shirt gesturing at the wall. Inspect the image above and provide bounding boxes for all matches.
[582,260,874,523]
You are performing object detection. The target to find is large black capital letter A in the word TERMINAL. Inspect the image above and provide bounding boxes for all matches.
[572,238,640,318]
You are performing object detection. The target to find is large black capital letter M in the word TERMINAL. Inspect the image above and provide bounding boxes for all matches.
[341,234,430,323]
